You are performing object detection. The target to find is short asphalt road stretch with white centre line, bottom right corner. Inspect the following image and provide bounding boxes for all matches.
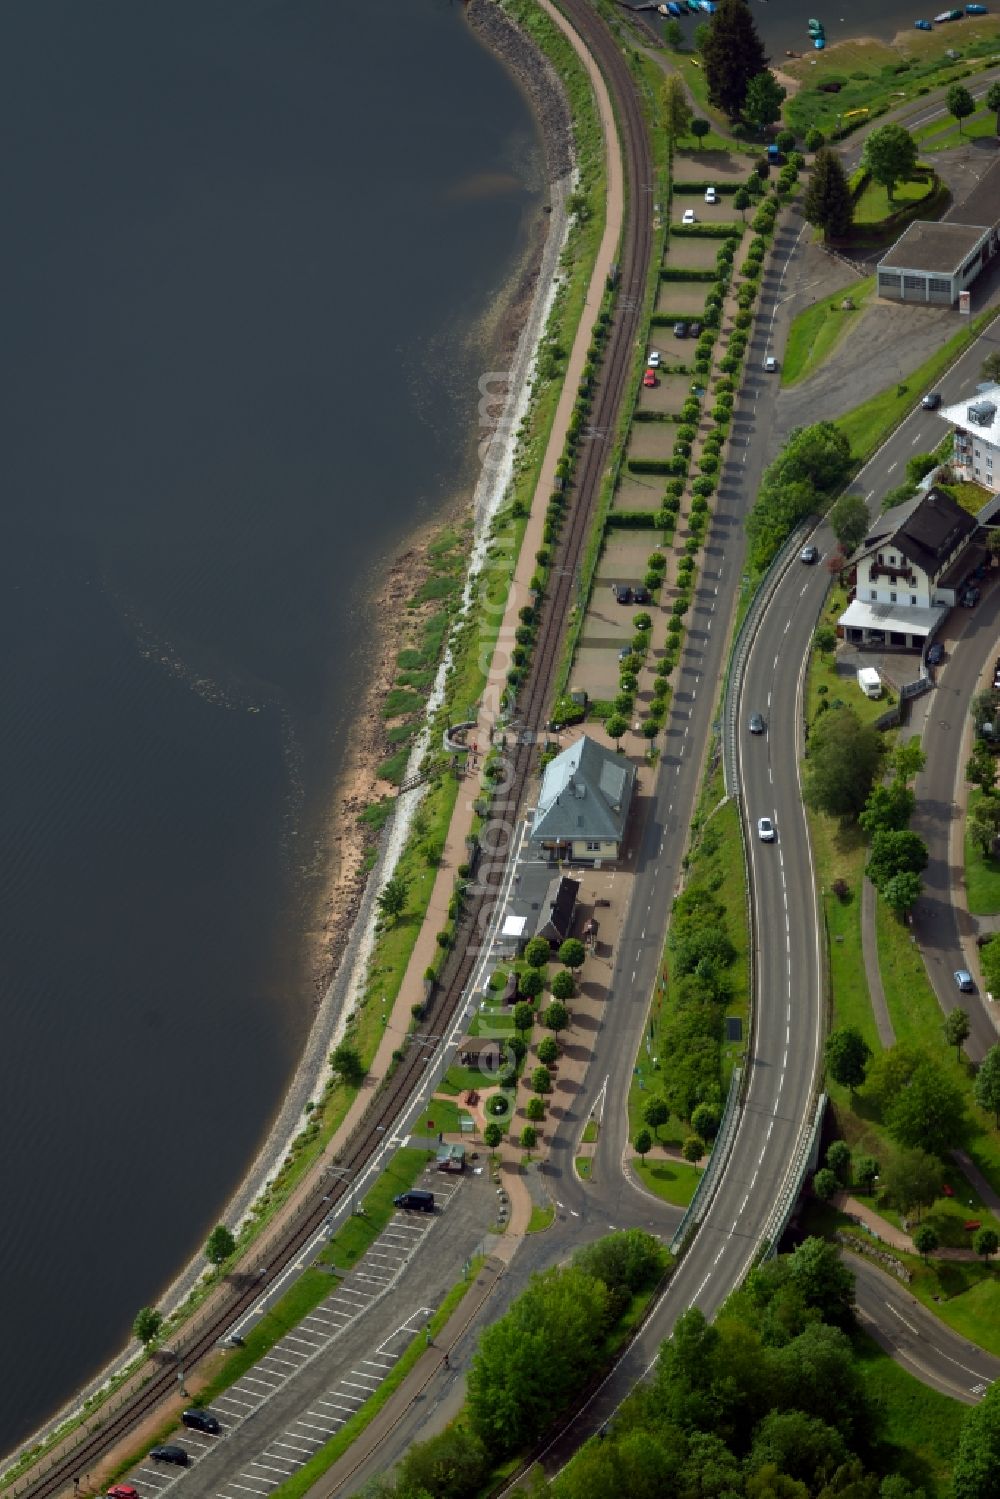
[844,1255,1000,1405]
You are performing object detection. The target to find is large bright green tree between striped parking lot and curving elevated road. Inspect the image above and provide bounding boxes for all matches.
[466,1265,607,1462]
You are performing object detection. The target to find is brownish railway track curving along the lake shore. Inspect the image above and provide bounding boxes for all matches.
[12,0,654,1499]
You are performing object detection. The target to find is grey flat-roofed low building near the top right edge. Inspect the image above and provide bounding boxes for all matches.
[877,219,1000,307]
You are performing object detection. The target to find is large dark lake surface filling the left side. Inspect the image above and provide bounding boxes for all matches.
[0,0,541,1451]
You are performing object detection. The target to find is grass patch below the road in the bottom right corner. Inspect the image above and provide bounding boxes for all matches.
[852,1331,966,1495]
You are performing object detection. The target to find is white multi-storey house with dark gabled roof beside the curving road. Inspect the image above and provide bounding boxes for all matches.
[838,489,982,649]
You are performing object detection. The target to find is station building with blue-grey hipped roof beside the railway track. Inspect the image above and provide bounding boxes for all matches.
[529,735,636,863]
